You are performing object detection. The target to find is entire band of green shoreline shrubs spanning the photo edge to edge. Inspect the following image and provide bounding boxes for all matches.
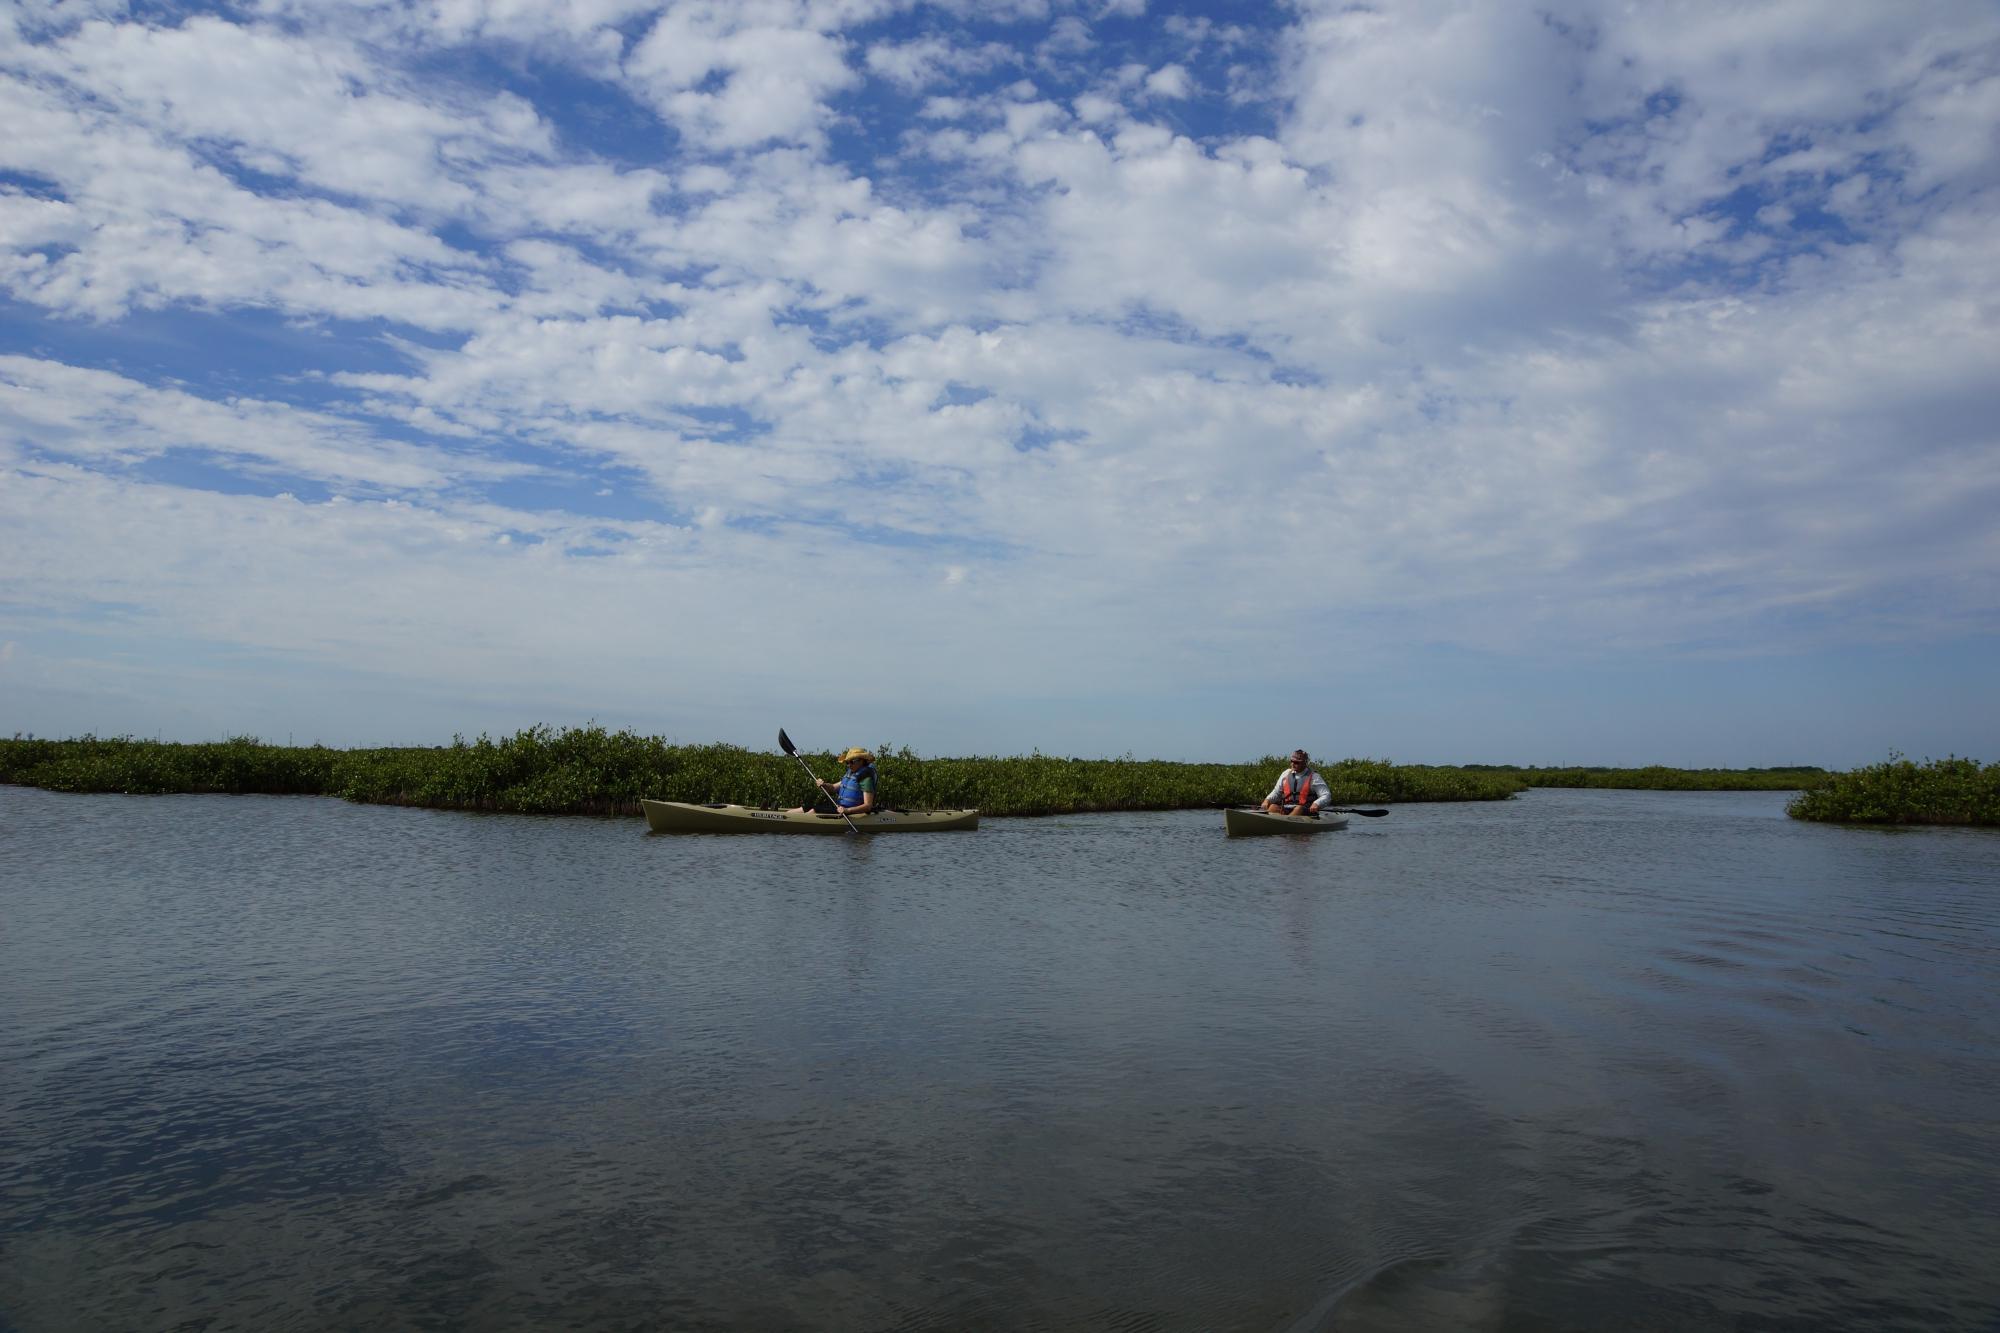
[0,725,1944,825]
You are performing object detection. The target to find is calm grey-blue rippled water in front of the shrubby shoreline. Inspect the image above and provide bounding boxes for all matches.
[0,787,2000,1331]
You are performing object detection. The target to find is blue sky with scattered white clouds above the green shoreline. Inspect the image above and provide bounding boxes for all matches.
[0,0,2000,769]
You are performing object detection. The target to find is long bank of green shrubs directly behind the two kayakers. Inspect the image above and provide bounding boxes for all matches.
[0,727,1522,815]
